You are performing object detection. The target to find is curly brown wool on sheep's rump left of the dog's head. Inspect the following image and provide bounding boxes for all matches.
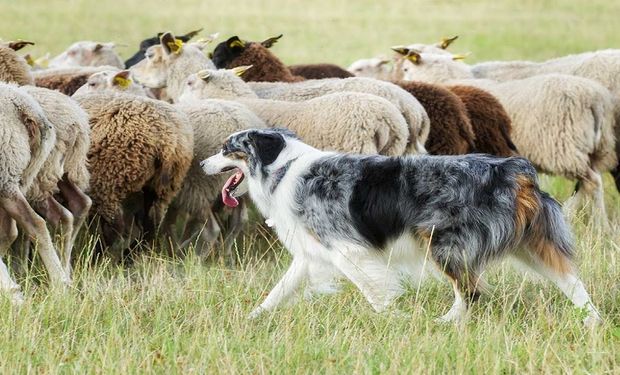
[75,92,193,223]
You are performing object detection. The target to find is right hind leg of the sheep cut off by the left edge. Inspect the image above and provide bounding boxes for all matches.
[0,191,71,285]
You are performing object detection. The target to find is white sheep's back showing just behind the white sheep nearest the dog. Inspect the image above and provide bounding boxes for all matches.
[248,77,430,153]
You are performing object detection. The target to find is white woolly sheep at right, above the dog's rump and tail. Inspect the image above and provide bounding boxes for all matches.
[396,51,618,225]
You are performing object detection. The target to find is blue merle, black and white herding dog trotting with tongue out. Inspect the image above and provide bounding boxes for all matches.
[201,129,600,324]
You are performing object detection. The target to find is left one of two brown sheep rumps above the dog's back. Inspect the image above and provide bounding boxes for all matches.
[396,81,475,155]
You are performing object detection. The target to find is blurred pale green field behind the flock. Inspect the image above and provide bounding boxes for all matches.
[0,0,620,65]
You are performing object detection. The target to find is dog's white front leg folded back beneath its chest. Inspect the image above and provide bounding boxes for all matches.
[336,248,403,312]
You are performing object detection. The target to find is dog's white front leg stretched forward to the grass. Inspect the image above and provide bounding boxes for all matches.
[249,257,308,319]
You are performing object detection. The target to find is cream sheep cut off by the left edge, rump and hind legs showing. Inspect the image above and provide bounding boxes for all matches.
[0,84,70,303]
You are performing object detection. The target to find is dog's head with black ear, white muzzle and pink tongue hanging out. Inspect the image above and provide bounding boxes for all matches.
[200,129,296,207]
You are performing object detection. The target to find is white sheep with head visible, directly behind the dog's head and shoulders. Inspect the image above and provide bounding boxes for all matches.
[179,67,410,156]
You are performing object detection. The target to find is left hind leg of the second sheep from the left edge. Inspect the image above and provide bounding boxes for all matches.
[41,197,75,275]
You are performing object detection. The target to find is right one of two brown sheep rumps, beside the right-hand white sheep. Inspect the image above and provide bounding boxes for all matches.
[448,85,518,157]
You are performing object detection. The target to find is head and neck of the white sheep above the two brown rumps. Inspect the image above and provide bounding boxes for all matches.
[394,48,473,83]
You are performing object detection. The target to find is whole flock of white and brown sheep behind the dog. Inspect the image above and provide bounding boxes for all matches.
[0,32,620,302]
